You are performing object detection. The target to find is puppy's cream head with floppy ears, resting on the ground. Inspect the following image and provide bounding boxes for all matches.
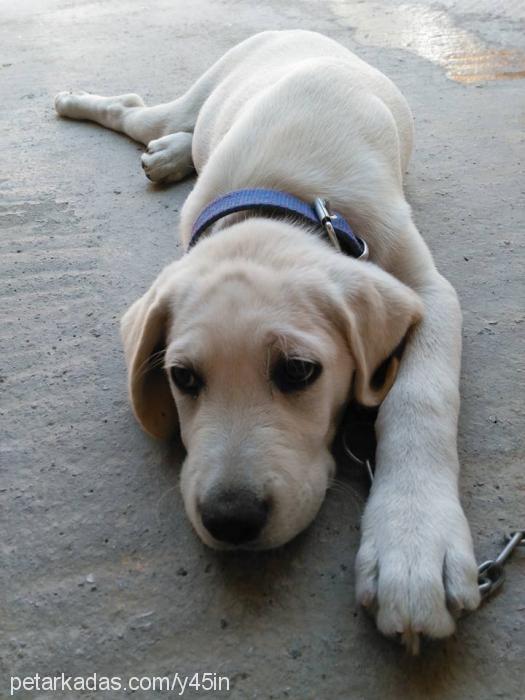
[122,219,422,549]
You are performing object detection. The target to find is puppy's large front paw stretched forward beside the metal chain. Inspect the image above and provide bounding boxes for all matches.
[356,493,480,653]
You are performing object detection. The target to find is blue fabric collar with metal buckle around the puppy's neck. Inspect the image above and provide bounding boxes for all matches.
[188,189,368,260]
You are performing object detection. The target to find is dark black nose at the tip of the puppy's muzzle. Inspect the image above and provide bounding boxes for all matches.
[200,490,269,544]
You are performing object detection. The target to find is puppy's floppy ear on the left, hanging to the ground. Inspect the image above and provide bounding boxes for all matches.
[120,273,178,439]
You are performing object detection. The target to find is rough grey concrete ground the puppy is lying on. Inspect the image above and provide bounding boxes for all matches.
[0,0,525,700]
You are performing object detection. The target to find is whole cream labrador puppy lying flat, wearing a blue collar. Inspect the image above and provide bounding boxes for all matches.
[55,31,479,644]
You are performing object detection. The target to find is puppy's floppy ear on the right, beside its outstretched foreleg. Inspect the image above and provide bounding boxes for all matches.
[334,261,423,406]
